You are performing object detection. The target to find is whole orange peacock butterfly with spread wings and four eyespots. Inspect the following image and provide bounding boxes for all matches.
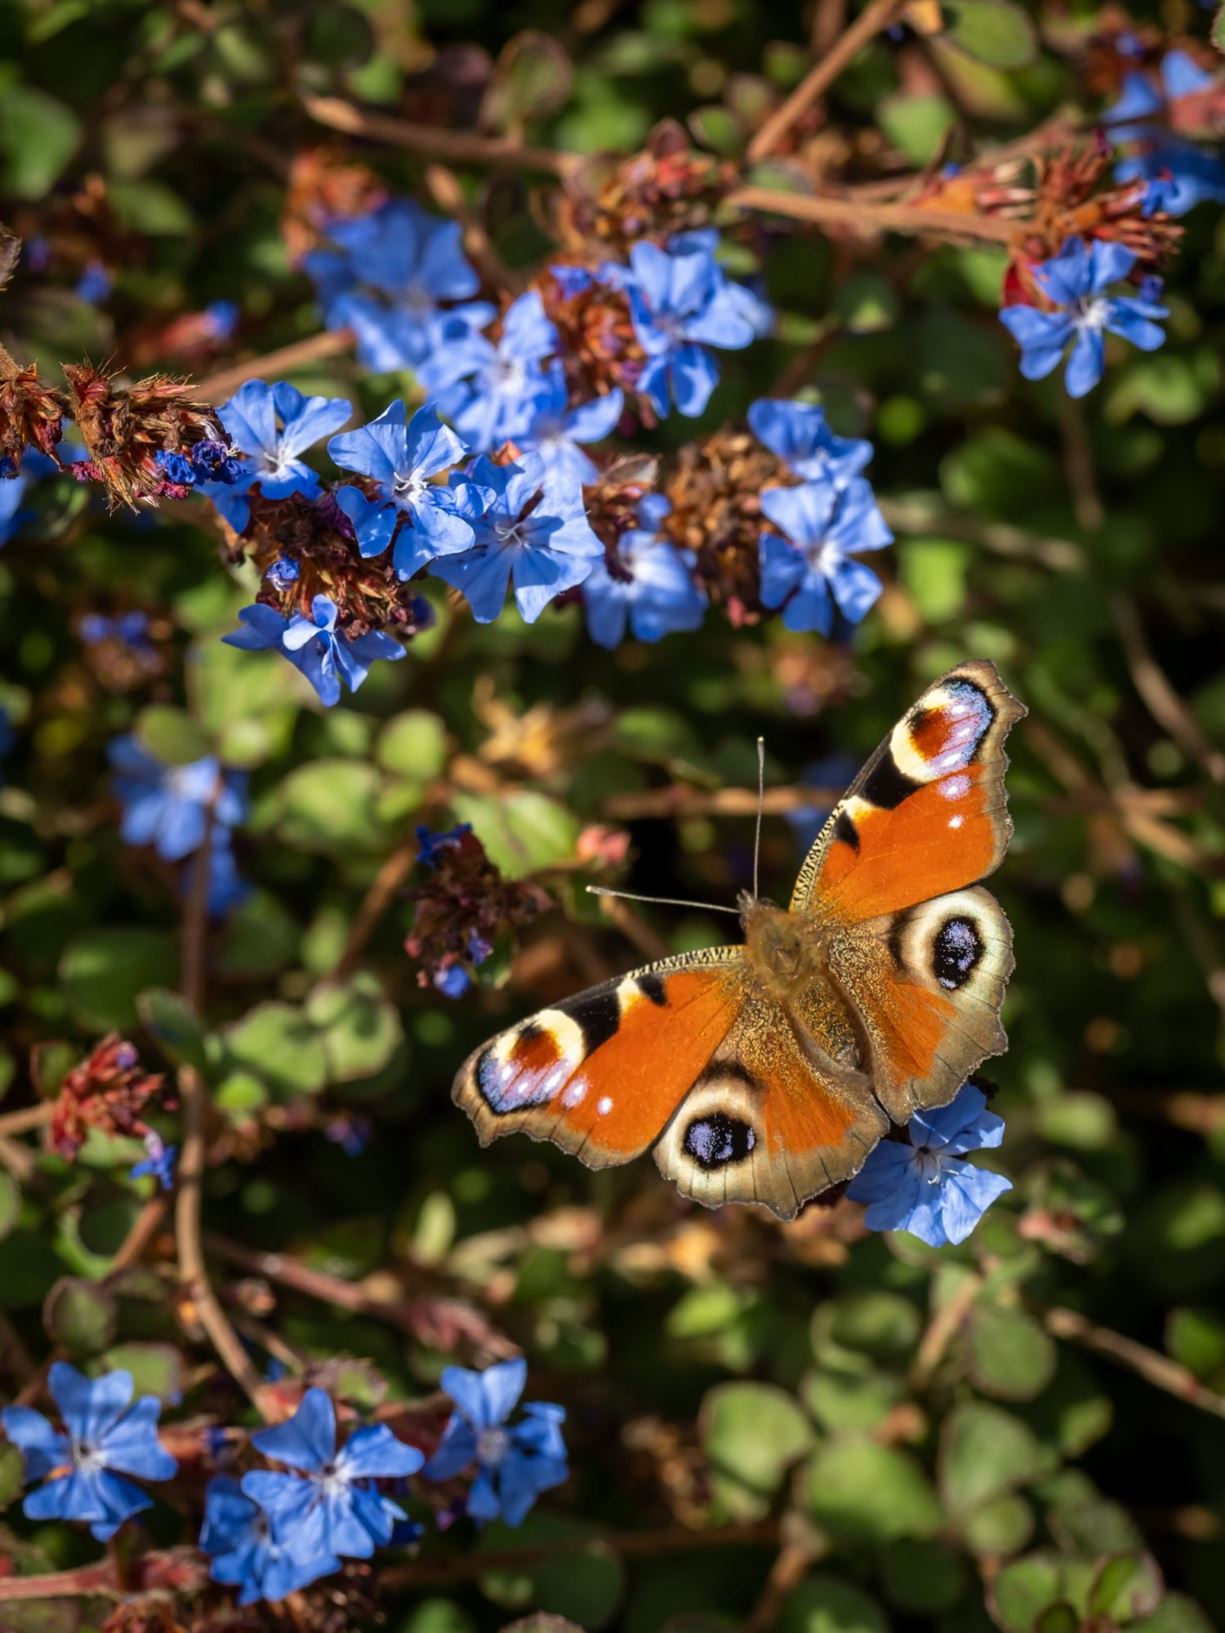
[452,661,1024,1218]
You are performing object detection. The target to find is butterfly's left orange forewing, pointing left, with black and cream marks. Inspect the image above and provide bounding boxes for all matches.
[451,947,745,1168]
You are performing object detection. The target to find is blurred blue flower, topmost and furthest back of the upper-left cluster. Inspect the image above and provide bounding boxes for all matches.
[305,199,493,374]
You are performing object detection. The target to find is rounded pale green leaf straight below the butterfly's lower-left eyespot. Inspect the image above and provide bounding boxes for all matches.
[699,1383,812,1519]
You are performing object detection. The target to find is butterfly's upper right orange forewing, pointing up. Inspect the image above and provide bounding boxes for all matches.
[791,660,1026,923]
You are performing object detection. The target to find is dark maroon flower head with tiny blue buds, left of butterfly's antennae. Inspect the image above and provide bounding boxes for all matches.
[403,823,544,998]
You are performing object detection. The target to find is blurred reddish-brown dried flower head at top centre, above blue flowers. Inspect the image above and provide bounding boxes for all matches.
[554,119,735,255]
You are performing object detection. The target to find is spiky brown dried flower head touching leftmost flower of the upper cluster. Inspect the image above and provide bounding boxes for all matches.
[64,363,229,506]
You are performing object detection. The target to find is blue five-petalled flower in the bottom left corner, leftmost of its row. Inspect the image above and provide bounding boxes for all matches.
[0,1360,178,1542]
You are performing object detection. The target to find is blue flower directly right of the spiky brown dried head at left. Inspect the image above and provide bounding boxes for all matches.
[199,380,353,532]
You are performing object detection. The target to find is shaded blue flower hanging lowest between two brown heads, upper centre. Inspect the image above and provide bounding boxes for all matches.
[583,495,707,647]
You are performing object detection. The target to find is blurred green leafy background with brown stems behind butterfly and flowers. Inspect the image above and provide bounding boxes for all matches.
[0,0,1225,1633]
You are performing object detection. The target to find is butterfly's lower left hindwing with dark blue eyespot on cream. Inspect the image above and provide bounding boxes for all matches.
[655,991,889,1220]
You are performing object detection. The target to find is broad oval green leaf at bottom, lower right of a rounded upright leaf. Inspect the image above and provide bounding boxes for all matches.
[805,1434,942,1546]
